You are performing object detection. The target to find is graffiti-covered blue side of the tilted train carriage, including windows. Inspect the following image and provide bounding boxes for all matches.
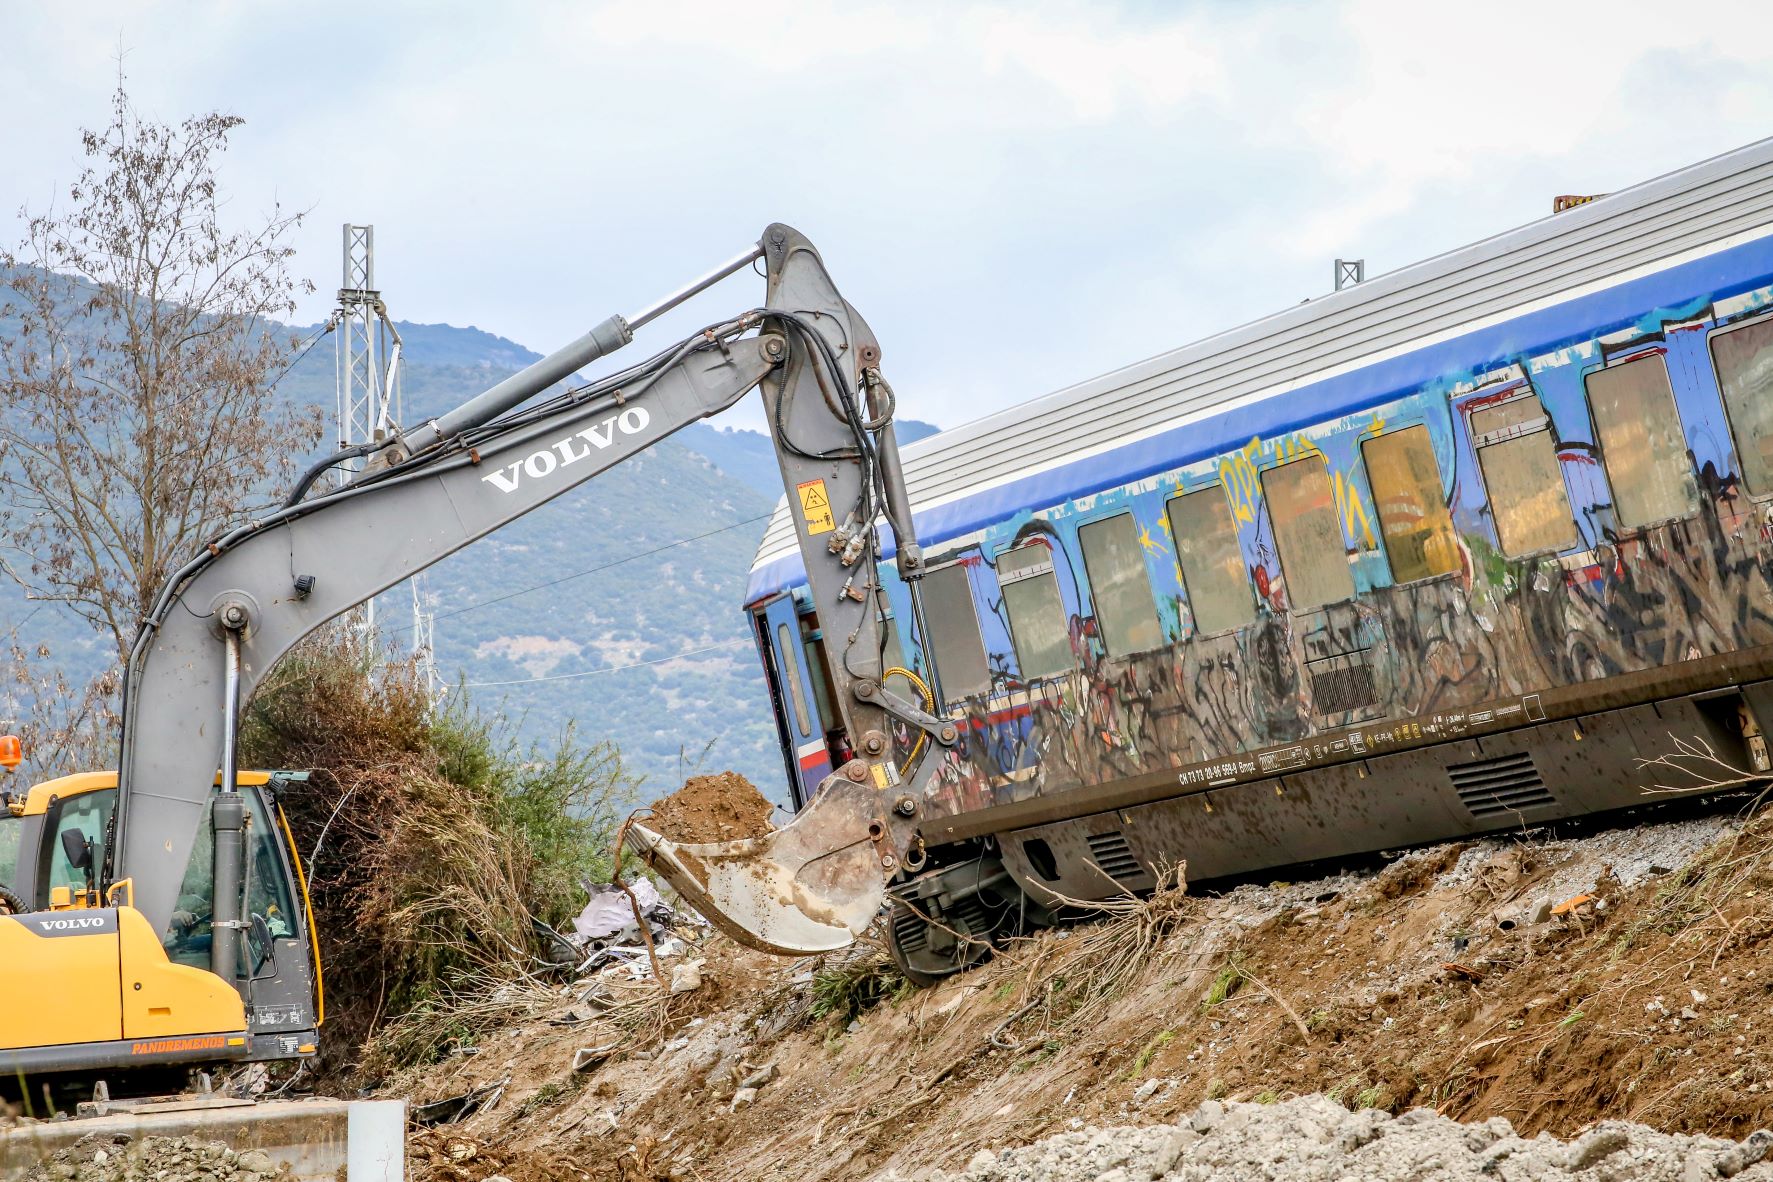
[881,287,1773,829]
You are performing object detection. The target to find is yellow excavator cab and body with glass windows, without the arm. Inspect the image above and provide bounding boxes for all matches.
[0,744,321,1076]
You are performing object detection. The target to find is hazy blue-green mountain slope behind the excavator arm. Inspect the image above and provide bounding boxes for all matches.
[0,310,934,801]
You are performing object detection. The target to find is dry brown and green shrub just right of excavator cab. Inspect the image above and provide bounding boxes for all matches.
[241,629,633,1069]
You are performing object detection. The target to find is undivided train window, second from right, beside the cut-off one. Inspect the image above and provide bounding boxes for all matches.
[1587,353,1699,526]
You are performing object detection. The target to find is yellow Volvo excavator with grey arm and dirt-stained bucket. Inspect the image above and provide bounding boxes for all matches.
[0,223,957,1083]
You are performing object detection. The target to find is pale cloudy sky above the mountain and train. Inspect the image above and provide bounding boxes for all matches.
[0,0,1773,437]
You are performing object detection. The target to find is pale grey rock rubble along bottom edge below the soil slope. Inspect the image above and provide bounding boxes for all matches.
[900,1095,1773,1182]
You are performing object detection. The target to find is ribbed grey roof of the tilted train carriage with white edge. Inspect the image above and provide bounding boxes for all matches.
[746,138,1773,603]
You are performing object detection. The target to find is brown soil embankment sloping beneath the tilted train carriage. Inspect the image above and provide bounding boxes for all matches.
[387,800,1773,1182]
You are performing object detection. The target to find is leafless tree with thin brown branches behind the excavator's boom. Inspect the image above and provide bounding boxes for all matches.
[0,80,321,659]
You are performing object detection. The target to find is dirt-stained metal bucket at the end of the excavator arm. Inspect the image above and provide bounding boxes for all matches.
[628,776,892,957]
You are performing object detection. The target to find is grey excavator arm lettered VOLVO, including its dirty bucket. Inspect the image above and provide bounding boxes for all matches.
[105,225,956,966]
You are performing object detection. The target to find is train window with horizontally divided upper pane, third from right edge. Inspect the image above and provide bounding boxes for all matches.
[1472,393,1576,558]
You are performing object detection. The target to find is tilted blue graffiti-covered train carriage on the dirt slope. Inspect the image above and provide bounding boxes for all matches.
[746,140,1773,978]
